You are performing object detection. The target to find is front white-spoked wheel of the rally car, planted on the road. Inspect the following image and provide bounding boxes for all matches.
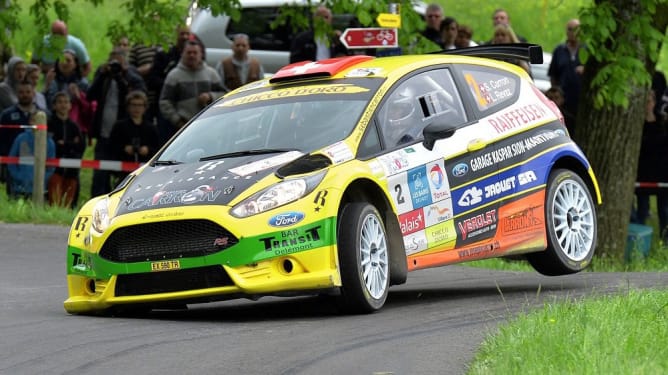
[338,203,390,313]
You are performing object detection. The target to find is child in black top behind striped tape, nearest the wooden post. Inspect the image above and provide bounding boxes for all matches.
[47,91,86,208]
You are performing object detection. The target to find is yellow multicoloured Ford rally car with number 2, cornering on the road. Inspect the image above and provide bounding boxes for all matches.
[64,45,601,314]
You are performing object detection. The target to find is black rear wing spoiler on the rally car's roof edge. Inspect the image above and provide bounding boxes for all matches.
[433,43,543,64]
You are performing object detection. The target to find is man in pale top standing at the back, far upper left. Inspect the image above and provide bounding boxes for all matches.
[32,20,92,77]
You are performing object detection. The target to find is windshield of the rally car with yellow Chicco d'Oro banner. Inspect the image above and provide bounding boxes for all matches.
[157,80,384,163]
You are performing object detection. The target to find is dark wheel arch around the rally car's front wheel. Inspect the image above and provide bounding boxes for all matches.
[337,178,408,285]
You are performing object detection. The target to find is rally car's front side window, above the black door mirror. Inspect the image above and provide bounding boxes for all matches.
[378,69,466,148]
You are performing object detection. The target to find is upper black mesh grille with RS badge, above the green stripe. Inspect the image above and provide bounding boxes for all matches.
[100,220,239,263]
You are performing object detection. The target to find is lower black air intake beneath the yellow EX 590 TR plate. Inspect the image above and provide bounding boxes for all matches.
[115,266,234,297]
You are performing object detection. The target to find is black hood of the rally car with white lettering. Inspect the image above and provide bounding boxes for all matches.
[117,151,301,215]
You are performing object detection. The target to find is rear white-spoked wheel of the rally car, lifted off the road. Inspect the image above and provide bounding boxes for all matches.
[527,169,596,276]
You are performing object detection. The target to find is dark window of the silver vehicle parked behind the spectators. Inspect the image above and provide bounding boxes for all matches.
[227,8,293,51]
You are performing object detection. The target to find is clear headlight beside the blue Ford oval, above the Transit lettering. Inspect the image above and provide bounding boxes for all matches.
[230,172,325,218]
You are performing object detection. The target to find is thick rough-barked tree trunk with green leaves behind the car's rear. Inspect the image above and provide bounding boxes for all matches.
[574,0,668,259]
